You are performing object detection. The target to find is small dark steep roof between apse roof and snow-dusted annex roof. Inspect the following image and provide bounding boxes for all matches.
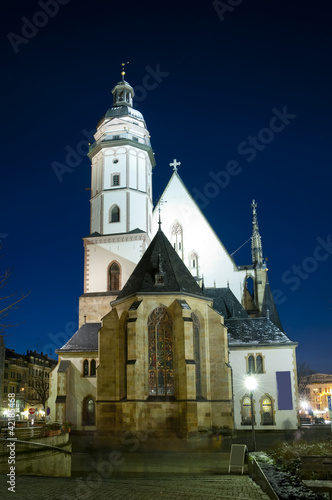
[204,288,248,319]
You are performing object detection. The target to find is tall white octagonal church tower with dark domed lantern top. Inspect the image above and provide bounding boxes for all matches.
[79,71,155,326]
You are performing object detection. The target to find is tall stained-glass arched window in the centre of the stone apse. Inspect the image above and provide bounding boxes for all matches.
[148,306,174,396]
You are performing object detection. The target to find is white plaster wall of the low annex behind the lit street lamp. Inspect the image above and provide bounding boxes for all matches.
[229,346,298,430]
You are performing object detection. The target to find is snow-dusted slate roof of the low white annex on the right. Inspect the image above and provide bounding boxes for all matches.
[225,318,296,347]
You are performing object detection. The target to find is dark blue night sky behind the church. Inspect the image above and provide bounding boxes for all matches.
[0,0,332,372]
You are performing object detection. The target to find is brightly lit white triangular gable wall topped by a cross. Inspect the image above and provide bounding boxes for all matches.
[153,174,245,302]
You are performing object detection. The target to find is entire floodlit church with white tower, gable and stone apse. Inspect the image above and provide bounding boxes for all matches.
[48,71,298,437]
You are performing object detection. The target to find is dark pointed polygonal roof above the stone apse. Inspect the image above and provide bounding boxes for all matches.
[117,229,203,300]
